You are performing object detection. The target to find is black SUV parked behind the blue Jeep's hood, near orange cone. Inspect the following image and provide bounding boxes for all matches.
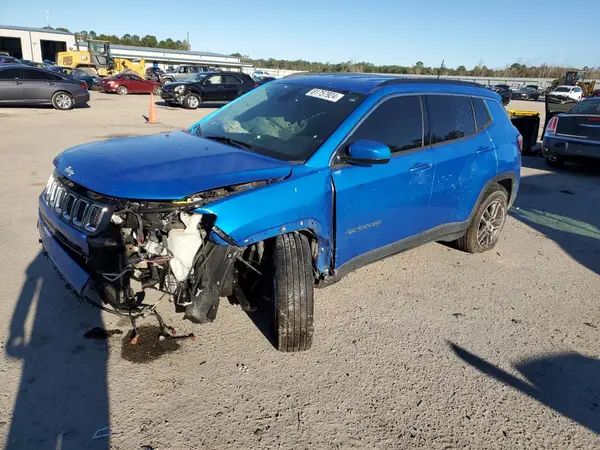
[160,72,257,109]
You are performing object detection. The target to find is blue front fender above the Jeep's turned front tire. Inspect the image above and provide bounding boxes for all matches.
[196,166,333,272]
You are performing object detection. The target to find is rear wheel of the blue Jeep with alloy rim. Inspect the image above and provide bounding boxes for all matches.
[455,184,508,253]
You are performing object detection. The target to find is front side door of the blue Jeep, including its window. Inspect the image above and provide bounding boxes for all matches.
[332,95,435,268]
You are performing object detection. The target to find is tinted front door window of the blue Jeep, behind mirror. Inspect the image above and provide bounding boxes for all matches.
[347,95,423,153]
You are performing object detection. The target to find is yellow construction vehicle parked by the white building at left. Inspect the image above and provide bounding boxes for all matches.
[56,35,146,78]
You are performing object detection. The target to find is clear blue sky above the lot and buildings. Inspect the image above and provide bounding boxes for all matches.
[0,0,600,69]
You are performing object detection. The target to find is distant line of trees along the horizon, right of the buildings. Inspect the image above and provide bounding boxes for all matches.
[231,53,600,78]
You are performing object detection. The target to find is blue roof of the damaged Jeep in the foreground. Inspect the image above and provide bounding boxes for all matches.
[282,73,491,94]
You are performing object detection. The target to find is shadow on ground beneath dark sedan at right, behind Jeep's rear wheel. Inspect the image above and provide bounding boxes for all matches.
[510,156,600,274]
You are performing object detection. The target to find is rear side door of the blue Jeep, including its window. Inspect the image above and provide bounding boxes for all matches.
[425,94,498,227]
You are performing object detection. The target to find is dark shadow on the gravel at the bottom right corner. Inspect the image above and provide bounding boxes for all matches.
[448,342,600,434]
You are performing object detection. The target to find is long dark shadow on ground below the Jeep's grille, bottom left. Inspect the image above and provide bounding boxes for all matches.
[5,254,110,450]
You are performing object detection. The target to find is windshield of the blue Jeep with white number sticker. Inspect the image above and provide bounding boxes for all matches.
[196,82,365,161]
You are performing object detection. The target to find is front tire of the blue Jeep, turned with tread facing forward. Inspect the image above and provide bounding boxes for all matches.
[273,233,314,352]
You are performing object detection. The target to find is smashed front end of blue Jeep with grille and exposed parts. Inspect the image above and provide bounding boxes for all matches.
[40,173,267,323]
